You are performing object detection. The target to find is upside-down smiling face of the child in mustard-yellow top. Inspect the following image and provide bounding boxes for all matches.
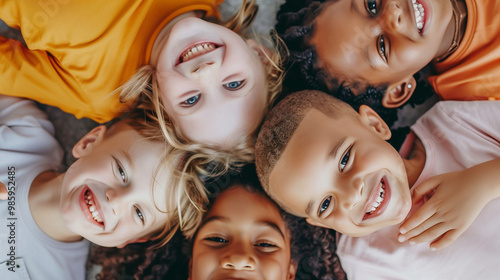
[157,18,267,147]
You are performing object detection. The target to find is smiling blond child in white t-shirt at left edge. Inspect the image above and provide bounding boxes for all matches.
[0,96,197,279]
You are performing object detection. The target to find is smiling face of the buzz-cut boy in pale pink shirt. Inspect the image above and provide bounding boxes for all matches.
[269,106,411,236]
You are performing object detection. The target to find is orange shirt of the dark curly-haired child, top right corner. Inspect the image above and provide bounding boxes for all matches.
[429,0,500,100]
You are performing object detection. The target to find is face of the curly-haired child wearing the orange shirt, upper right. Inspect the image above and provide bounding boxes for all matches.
[311,0,453,92]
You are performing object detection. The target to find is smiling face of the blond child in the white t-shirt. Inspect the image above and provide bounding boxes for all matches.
[60,124,170,247]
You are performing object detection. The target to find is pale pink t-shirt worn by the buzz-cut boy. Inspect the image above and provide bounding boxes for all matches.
[337,101,500,280]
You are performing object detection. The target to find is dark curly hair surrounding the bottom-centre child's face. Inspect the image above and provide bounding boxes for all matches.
[88,164,346,280]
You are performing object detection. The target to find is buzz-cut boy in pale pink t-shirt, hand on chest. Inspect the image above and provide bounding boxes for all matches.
[256,92,500,279]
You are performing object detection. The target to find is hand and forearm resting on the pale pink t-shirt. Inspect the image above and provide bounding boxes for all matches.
[398,158,500,250]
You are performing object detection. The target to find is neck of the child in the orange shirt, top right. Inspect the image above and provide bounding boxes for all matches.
[435,0,467,62]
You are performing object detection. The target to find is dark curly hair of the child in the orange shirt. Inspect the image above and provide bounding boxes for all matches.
[275,0,434,147]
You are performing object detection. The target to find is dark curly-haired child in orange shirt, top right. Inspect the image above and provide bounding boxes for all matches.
[276,0,500,124]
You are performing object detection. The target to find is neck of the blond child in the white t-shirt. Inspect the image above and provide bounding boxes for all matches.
[28,171,82,242]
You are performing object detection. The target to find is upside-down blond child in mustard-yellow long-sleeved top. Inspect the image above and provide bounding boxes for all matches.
[0,0,279,147]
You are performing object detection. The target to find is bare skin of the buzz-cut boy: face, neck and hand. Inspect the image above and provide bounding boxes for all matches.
[268,105,500,249]
